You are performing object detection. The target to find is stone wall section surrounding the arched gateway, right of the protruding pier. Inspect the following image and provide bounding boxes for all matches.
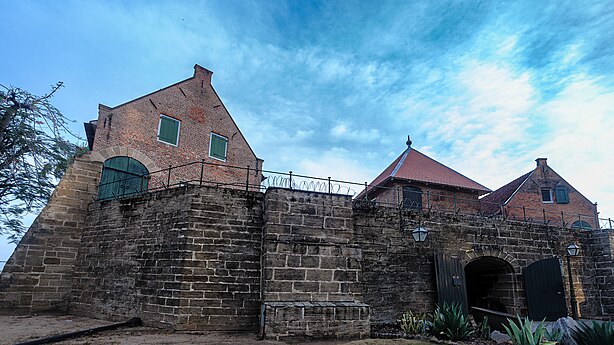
[354,204,599,324]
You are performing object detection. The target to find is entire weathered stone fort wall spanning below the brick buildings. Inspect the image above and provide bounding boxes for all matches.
[0,181,614,339]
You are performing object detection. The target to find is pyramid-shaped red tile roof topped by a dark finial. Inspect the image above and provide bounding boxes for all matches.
[370,147,490,194]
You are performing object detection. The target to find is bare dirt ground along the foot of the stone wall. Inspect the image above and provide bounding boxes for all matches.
[0,315,428,345]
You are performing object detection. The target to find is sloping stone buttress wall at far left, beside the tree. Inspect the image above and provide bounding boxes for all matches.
[0,154,102,313]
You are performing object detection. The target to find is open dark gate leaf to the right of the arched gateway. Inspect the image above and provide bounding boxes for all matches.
[522,257,567,321]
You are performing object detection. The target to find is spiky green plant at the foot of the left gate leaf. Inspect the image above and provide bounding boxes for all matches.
[431,303,473,341]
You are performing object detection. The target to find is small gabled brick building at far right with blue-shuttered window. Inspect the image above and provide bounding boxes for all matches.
[481,158,599,229]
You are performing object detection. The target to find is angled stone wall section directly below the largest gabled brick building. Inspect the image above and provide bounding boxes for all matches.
[70,187,262,331]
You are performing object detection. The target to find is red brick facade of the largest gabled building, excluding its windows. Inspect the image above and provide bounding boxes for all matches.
[92,65,263,189]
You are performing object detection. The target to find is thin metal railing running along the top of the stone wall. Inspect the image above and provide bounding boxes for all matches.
[96,160,614,229]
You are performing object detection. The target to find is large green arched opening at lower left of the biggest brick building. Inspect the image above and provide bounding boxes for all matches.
[98,157,149,200]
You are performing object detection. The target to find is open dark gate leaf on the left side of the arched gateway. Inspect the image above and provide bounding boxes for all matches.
[435,253,469,315]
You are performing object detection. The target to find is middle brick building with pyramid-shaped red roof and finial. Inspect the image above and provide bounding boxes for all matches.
[356,138,490,213]
